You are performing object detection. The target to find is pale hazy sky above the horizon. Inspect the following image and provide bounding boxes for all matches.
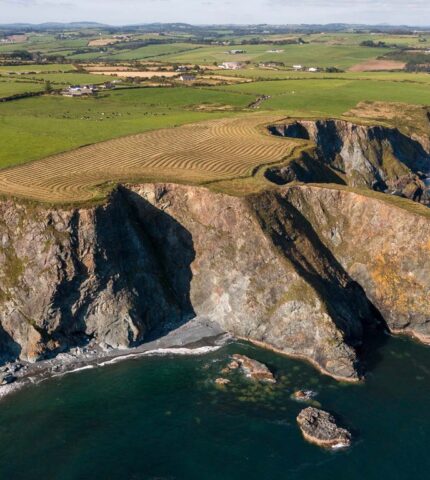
[0,0,430,25]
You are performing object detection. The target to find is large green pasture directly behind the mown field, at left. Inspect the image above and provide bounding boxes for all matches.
[0,88,254,167]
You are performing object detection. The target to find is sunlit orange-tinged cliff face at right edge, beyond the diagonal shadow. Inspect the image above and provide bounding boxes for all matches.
[284,186,430,342]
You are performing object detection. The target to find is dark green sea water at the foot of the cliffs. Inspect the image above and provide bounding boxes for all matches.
[0,339,430,480]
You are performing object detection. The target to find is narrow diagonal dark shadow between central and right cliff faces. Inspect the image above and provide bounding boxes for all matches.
[250,193,388,376]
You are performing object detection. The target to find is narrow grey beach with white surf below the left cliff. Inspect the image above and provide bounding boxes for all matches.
[0,317,233,401]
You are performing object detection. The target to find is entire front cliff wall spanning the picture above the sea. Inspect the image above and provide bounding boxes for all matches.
[0,184,430,380]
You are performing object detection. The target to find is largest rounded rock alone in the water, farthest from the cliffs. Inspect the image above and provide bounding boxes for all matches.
[297,407,351,448]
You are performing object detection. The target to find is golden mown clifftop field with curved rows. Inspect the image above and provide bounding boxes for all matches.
[0,114,297,202]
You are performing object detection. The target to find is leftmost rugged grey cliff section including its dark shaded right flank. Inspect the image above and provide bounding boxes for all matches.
[0,189,183,361]
